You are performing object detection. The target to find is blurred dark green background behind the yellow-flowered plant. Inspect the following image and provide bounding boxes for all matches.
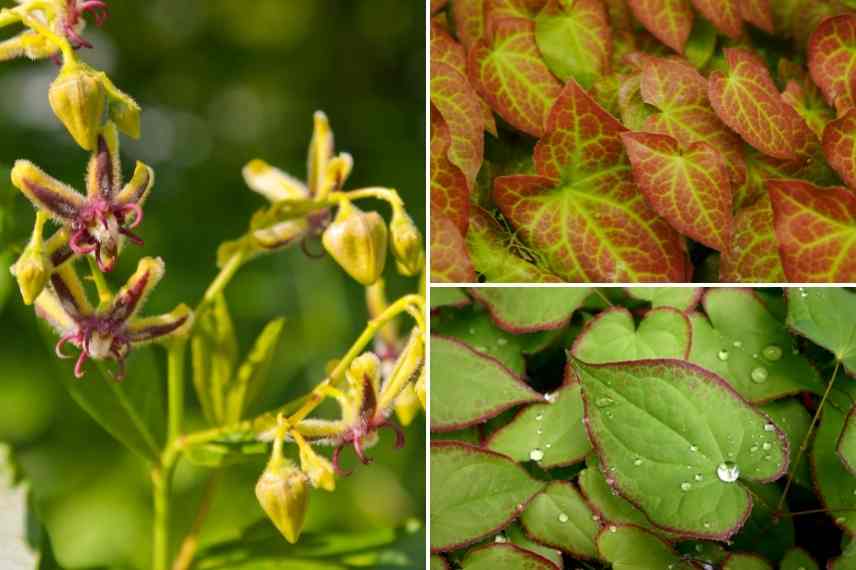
[0,0,425,568]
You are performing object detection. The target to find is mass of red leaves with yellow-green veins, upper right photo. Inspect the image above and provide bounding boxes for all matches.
[430,0,856,283]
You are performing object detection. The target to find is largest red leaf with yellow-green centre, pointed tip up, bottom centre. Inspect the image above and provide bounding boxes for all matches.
[494,80,689,282]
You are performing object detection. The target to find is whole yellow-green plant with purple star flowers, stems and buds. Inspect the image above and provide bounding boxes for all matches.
[0,0,426,570]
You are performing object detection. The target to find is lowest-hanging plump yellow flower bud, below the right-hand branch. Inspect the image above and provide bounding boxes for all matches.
[256,452,309,544]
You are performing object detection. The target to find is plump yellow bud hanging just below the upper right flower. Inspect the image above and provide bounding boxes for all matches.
[321,202,387,285]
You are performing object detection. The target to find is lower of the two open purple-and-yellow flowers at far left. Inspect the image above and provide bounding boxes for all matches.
[35,257,192,379]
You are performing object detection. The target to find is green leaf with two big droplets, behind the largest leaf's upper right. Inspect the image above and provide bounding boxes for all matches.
[690,289,823,402]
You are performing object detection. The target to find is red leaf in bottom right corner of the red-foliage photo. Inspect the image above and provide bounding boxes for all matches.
[767,180,856,283]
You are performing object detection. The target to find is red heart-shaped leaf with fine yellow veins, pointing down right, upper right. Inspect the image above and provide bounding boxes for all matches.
[709,48,807,160]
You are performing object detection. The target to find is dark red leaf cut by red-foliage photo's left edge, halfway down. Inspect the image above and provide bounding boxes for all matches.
[431,105,470,234]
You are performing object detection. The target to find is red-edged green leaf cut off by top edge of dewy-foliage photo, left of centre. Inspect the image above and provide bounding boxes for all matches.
[470,287,591,334]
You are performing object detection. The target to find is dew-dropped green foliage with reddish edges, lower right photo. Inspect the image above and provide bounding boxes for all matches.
[430,287,856,570]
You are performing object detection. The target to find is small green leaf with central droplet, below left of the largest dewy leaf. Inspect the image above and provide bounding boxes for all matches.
[521,481,600,558]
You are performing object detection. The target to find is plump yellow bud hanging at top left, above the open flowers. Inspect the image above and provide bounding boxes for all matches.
[48,62,107,150]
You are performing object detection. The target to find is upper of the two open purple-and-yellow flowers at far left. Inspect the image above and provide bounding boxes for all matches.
[12,122,154,271]
